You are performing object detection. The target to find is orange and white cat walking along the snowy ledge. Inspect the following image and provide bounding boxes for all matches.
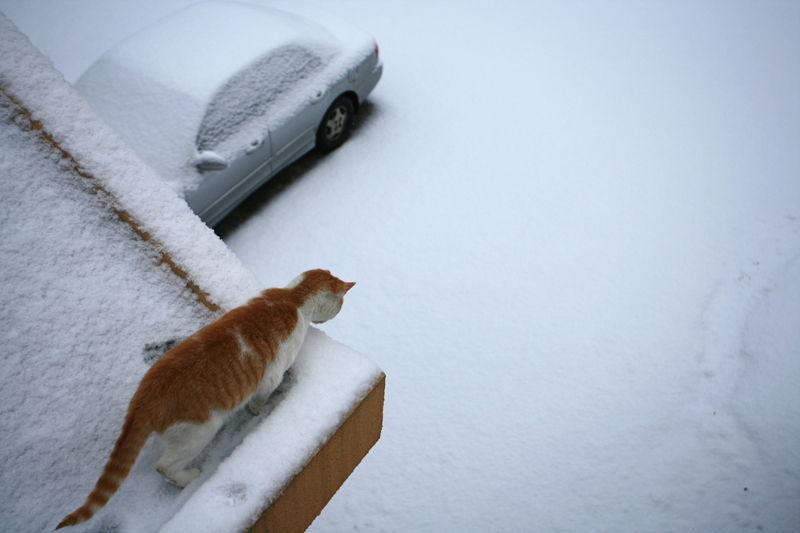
[56,270,355,529]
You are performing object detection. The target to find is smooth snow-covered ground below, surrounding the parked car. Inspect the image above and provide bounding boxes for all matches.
[0,0,800,532]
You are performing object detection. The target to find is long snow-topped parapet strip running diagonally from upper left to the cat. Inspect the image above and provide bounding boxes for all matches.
[0,10,262,310]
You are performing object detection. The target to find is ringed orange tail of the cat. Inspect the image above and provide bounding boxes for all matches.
[56,412,153,529]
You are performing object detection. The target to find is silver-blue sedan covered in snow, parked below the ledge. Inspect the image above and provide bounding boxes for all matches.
[75,1,383,226]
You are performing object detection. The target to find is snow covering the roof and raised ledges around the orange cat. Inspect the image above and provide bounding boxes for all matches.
[0,14,381,532]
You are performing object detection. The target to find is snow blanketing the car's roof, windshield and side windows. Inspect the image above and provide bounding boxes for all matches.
[75,1,374,196]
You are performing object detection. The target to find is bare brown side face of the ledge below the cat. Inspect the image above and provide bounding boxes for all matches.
[248,374,386,533]
